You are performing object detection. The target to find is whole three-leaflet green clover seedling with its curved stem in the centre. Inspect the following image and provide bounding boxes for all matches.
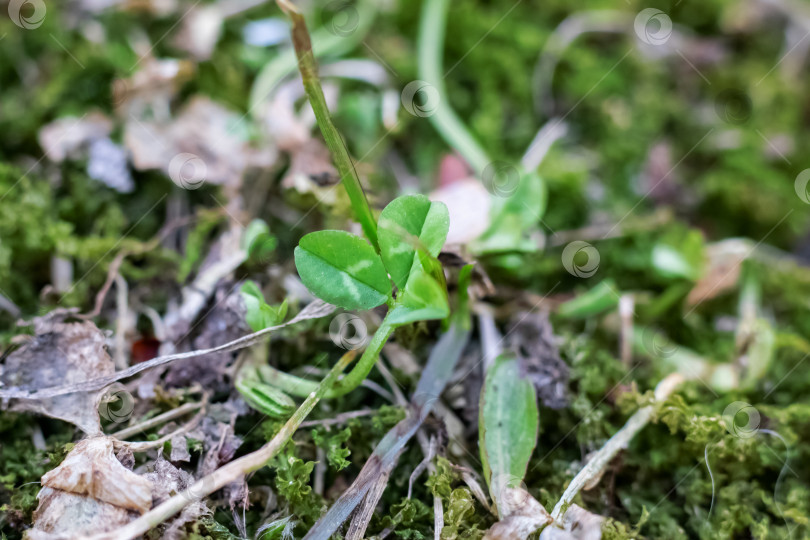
[252,195,450,396]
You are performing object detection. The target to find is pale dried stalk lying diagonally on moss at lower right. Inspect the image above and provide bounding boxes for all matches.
[551,373,686,523]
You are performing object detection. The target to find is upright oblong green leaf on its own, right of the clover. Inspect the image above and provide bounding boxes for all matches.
[478,355,539,516]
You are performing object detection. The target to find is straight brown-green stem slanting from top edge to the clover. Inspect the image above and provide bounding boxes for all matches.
[277,0,380,253]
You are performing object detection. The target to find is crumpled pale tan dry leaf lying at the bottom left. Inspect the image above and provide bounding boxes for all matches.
[42,436,152,513]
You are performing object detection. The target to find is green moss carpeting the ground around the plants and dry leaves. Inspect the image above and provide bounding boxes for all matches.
[0,0,810,539]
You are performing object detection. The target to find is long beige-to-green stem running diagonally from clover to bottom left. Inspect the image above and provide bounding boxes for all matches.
[91,354,354,540]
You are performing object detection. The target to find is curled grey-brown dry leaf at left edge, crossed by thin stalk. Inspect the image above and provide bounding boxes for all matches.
[0,314,115,435]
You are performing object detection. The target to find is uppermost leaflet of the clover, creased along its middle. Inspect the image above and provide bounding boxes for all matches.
[377,195,450,290]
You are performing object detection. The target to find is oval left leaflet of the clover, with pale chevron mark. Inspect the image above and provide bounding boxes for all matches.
[295,231,391,309]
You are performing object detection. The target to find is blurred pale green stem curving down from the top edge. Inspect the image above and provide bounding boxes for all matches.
[418,0,492,175]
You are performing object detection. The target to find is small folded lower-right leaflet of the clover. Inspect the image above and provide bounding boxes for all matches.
[385,267,450,325]
